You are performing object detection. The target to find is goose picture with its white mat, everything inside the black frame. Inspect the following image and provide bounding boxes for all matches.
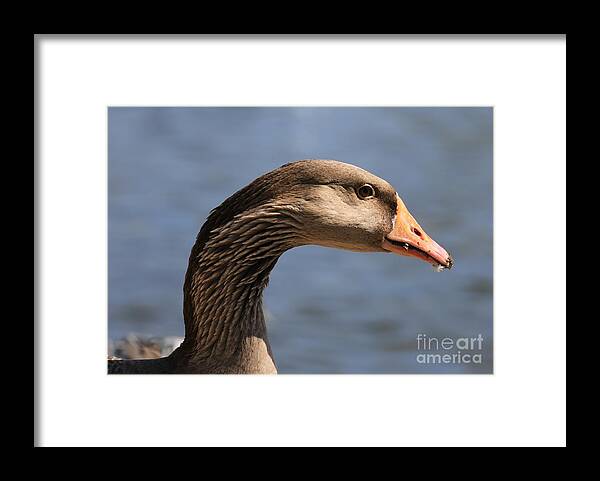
[33,34,567,448]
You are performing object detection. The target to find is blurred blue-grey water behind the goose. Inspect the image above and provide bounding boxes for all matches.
[108,108,493,373]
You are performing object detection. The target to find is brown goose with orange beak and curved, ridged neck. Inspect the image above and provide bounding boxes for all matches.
[108,160,454,374]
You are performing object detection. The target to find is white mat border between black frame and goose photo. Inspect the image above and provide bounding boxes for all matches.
[36,37,566,446]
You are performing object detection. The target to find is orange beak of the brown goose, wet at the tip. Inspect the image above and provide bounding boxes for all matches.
[381,194,454,269]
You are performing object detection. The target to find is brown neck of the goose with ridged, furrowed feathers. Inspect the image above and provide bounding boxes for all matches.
[179,164,318,370]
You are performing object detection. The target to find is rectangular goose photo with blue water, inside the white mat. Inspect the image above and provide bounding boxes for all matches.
[108,107,493,374]
